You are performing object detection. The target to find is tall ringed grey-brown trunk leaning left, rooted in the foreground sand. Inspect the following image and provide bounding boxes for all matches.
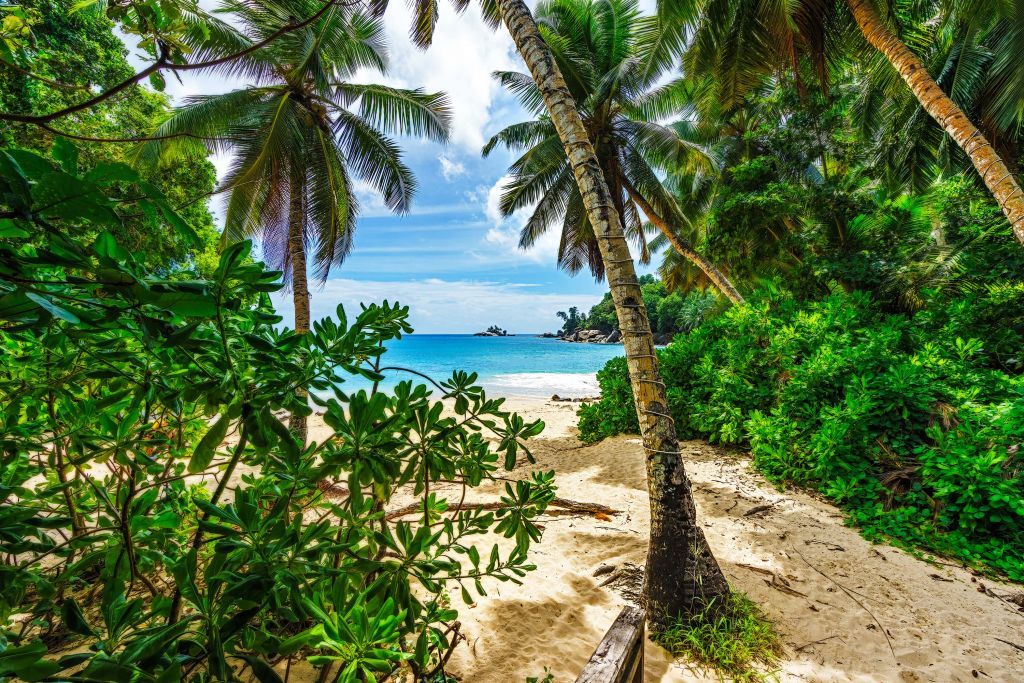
[498,0,729,628]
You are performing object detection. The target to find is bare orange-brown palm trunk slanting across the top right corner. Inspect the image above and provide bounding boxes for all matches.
[847,0,1024,245]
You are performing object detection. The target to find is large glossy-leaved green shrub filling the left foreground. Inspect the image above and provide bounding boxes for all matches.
[0,143,554,681]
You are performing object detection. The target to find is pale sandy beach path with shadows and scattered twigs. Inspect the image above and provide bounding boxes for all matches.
[310,398,1024,683]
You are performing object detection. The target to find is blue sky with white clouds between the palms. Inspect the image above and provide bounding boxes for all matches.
[125,1,655,333]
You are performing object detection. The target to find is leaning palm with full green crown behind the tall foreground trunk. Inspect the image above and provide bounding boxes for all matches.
[483,0,742,303]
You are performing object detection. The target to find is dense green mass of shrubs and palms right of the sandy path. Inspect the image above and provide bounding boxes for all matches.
[580,3,1024,581]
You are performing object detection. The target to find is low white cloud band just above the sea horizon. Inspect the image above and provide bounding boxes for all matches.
[274,279,600,333]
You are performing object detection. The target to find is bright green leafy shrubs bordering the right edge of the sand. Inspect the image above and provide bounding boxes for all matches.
[580,286,1024,581]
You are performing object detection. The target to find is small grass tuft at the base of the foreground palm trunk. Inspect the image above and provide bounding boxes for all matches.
[654,592,781,682]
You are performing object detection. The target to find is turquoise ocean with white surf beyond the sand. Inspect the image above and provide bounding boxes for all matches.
[345,334,623,398]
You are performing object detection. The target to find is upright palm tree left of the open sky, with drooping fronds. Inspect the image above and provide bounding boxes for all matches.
[142,0,450,434]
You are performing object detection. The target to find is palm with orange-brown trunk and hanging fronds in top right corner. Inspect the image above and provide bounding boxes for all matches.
[647,0,1024,244]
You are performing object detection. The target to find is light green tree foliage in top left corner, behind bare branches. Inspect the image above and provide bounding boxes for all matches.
[0,0,219,274]
